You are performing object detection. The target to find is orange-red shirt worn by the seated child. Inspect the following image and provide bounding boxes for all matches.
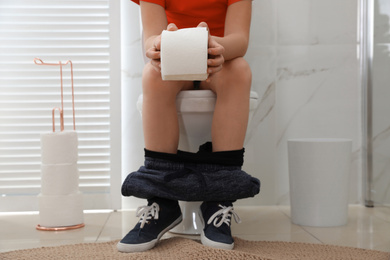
[131,0,241,37]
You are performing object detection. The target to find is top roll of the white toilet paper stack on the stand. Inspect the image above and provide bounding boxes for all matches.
[41,131,78,164]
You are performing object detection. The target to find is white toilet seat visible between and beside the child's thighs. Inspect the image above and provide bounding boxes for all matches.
[137,90,259,113]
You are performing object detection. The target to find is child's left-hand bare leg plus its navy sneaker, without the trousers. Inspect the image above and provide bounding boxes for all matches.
[117,63,192,252]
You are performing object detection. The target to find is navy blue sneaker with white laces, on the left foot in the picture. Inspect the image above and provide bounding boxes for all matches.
[117,198,182,253]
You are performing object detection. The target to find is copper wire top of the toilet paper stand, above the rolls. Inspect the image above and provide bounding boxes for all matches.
[34,58,76,132]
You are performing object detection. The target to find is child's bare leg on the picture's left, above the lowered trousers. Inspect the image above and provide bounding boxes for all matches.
[142,64,192,153]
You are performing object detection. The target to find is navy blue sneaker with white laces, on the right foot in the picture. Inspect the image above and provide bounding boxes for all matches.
[200,202,241,250]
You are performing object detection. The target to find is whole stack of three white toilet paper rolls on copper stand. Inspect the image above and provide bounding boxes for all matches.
[38,131,84,228]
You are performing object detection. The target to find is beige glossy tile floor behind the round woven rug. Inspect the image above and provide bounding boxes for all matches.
[0,205,390,252]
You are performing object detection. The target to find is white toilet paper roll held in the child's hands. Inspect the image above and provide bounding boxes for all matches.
[161,27,208,80]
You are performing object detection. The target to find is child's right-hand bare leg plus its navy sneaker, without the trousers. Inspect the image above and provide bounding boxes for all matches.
[197,58,251,249]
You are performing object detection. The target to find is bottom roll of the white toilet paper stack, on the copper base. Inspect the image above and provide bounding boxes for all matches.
[38,192,84,227]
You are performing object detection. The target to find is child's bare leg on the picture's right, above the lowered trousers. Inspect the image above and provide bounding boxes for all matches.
[201,55,252,152]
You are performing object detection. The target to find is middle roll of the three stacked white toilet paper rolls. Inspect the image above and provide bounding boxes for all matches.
[41,163,79,195]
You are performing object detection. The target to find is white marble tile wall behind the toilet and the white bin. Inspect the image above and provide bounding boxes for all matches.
[122,0,362,208]
